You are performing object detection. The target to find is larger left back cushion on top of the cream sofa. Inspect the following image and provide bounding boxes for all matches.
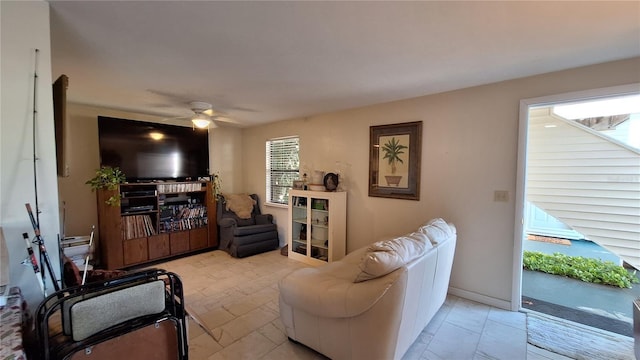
[353,232,432,283]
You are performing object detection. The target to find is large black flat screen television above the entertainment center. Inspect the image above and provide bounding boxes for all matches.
[98,116,209,182]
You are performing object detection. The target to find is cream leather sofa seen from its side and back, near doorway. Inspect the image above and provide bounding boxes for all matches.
[279,219,456,360]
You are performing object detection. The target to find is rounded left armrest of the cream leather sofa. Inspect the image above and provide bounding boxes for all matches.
[279,263,407,318]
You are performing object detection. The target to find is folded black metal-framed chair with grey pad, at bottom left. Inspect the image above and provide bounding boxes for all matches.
[36,269,188,360]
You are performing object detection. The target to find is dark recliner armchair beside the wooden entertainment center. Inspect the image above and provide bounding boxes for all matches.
[217,194,280,258]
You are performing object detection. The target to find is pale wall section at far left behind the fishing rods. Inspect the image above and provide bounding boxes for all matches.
[0,1,60,310]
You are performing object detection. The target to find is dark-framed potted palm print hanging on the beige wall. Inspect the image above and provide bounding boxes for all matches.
[369,121,422,200]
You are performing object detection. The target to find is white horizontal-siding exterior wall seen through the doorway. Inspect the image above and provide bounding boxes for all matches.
[526,108,640,269]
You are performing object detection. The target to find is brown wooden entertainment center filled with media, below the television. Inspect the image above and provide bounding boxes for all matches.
[98,181,218,270]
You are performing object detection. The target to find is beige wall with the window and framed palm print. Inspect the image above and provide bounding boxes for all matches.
[242,58,640,308]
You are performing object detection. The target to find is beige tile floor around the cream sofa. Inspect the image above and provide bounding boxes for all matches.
[155,251,567,360]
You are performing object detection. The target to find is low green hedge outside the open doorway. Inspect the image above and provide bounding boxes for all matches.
[522,251,638,288]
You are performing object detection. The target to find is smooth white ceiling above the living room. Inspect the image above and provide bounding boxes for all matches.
[50,1,640,126]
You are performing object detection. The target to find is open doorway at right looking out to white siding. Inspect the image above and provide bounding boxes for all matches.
[513,85,640,336]
